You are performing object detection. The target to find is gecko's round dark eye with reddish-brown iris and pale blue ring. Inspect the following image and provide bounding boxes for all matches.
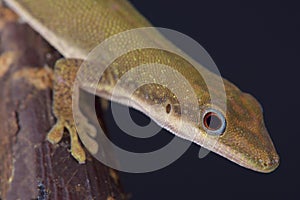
[202,109,226,135]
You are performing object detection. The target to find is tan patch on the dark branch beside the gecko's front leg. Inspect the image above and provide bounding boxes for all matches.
[13,68,53,90]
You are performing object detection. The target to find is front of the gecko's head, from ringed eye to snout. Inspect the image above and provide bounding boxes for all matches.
[197,80,279,173]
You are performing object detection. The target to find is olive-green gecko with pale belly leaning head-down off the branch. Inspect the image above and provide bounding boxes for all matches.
[5,0,279,173]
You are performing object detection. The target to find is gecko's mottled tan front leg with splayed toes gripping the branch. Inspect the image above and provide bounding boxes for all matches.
[47,59,93,163]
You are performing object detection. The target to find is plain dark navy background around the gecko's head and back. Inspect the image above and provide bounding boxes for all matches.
[101,0,300,200]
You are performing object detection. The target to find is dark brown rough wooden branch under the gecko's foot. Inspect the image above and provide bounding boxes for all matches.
[0,7,125,200]
